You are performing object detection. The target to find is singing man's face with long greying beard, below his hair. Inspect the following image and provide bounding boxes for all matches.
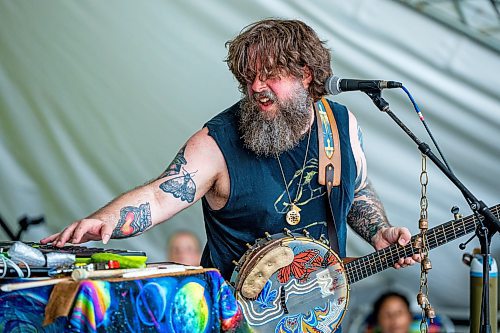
[239,67,312,156]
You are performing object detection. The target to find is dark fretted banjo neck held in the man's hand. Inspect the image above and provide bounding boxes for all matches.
[344,204,500,284]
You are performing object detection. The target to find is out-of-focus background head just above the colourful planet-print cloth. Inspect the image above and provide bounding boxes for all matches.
[167,230,201,266]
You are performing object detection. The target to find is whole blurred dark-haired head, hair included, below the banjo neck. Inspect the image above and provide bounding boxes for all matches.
[373,292,413,333]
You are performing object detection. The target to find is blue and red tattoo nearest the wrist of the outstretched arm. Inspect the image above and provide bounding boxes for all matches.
[111,202,153,238]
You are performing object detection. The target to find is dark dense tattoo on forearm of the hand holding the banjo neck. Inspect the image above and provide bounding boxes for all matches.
[347,183,391,244]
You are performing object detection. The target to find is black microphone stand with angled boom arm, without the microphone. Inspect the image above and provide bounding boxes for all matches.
[363,88,500,333]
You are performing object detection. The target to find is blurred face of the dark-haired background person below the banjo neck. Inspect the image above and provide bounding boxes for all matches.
[377,297,412,333]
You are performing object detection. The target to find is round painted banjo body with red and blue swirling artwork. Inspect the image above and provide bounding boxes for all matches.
[231,235,349,333]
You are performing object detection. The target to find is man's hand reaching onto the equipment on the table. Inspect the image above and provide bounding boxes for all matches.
[40,219,114,247]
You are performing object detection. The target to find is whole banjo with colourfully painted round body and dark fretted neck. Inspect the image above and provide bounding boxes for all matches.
[230,205,500,333]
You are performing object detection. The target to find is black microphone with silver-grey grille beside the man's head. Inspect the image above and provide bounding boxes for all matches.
[325,76,403,95]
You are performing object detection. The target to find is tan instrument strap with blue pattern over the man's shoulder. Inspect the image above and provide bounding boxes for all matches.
[314,98,341,253]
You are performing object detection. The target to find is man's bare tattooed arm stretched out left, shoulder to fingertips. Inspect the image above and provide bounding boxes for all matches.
[40,128,227,246]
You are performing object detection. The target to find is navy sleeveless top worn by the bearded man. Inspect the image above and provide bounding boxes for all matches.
[201,101,356,280]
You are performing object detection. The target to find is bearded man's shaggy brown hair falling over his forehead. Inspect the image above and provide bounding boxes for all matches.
[225,19,332,101]
